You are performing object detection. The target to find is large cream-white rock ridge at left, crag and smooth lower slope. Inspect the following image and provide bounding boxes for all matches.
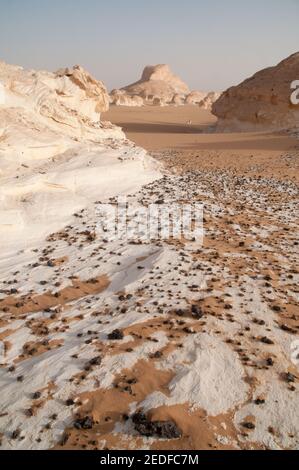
[0,62,162,254]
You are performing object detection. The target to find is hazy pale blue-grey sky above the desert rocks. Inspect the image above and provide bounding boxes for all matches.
[0,0,299,91]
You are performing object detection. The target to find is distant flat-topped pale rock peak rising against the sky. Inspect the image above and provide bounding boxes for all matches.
[123,65,190,103]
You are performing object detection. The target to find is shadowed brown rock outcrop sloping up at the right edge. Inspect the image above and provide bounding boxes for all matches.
[212,52,299,129]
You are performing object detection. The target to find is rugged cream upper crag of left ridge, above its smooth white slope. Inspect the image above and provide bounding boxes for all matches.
[0,62,125,166]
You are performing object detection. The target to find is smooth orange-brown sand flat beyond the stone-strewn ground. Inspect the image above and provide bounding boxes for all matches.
[103,105,299,181]
